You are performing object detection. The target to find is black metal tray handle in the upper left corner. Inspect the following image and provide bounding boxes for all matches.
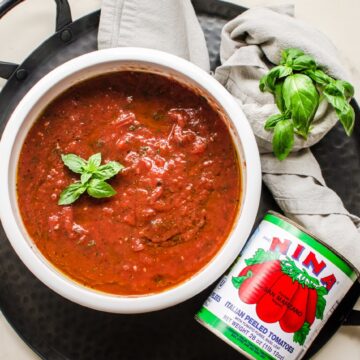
[0,0,72,80]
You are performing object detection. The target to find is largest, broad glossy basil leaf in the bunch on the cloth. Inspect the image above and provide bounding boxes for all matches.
[283,74,319,138]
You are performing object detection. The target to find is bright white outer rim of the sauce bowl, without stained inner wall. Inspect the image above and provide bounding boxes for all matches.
[0,47,261,314]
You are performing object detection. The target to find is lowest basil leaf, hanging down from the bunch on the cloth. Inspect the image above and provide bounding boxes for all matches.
[273,119,294,160]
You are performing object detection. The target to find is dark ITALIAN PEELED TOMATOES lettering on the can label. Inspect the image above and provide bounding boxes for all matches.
[225,301,294,354]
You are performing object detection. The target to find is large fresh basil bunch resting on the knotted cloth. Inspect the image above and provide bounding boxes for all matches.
[259,49,355,160]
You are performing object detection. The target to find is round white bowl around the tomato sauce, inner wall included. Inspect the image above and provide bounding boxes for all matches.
[0,48,261,313]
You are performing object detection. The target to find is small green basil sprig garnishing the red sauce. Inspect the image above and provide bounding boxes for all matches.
[58,153,124,205]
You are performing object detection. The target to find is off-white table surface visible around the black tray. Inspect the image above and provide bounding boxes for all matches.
[0,0,360,360]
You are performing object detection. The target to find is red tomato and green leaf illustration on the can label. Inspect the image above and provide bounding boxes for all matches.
[232,249,328,345]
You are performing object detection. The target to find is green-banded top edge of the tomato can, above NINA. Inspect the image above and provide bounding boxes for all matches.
[264,211,358,281]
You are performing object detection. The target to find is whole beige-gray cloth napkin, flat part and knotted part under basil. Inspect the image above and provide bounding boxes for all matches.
[98,0,360,271]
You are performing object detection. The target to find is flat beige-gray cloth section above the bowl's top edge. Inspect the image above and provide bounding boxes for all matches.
[98,0,210,71]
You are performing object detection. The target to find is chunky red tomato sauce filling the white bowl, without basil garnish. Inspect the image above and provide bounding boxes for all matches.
[17,72,241,295]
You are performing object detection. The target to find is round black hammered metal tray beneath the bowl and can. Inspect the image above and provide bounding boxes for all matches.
[0,0,360,360]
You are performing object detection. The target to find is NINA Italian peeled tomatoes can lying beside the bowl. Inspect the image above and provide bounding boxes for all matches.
[196,212,358,359]
